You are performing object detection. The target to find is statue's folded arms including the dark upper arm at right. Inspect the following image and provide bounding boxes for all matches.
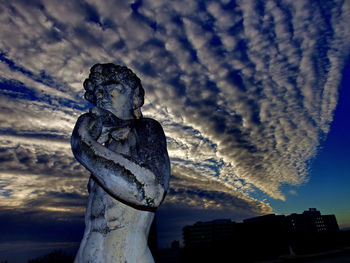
[71,113,170,210]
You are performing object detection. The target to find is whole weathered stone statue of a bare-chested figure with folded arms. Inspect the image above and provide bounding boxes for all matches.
[71,64,170,263]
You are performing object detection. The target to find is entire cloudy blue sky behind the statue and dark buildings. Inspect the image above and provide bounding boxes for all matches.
[0,0,350,263]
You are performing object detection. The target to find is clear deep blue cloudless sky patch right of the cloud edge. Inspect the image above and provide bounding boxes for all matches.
[271,64,350,228]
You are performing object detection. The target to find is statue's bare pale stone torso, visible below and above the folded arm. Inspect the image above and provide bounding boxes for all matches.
[76,126,154,263]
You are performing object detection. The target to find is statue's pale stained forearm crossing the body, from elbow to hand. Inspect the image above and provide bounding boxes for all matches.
[71,113,170,209]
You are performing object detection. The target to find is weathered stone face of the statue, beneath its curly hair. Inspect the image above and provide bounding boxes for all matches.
[97,83,134,116]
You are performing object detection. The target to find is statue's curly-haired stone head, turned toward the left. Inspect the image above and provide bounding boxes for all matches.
[84,63,145,118]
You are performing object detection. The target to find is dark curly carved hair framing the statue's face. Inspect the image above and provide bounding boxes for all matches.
[84,63,145,117]
